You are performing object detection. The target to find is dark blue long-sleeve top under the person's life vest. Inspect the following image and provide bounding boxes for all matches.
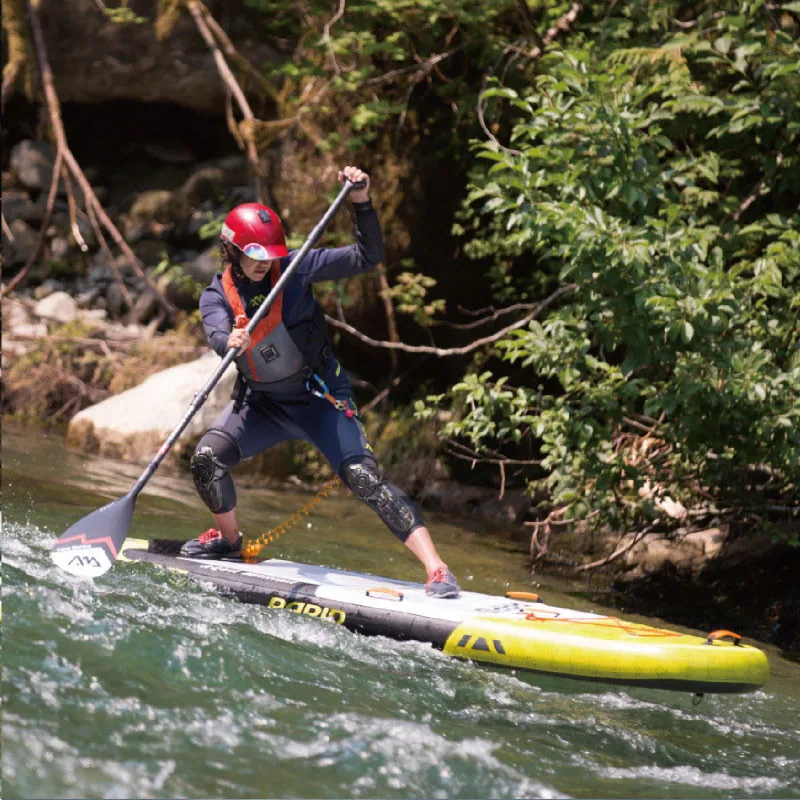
[200,200,384,356]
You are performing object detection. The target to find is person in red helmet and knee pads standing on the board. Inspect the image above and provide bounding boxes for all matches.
[181,166,459,598]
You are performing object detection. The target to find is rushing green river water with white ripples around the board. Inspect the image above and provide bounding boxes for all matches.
[2,426,800,799]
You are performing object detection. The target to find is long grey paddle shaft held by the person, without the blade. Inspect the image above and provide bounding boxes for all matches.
[130,180,364,497]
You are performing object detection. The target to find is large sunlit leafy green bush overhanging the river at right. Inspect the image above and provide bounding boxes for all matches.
[432,0,800,529]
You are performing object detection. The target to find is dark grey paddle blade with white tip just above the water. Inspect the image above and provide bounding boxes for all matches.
[50,494,136,578]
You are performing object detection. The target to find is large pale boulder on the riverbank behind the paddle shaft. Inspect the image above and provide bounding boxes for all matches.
[67,352,236,463]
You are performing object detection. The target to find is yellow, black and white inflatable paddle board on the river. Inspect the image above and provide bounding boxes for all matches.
[121,539,769,693]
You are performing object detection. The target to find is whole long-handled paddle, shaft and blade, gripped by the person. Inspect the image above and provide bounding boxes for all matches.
[50,180,366,578]
